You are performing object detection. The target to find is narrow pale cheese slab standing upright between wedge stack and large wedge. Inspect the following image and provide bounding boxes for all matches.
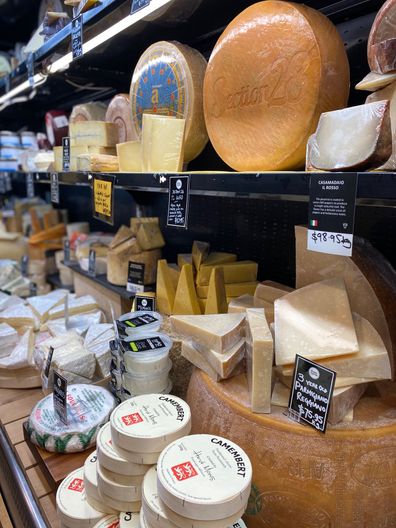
[246,308,274,413]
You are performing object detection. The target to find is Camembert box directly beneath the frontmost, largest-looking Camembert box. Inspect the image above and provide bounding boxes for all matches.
[142,466,245,528]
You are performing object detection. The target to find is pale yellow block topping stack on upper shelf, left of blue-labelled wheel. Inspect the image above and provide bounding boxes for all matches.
[69,121,118,147]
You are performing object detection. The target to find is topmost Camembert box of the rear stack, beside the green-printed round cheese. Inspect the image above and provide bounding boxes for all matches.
[110,394,191,453]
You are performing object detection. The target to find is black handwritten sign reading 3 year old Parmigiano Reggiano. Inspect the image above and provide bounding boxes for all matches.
[289,354,336,433]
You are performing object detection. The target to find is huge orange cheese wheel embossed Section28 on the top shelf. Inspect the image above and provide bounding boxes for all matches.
[204,0,349,171]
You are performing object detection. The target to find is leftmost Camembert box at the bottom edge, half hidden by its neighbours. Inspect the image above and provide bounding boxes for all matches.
[56,468,104,528]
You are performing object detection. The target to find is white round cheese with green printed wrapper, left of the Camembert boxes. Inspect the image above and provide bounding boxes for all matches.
[28,384,115,453]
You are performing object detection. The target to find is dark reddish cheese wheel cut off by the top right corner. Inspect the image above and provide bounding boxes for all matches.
[367,0,396,73]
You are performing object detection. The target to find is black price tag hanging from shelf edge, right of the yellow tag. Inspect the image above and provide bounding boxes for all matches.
[167,176,190,229]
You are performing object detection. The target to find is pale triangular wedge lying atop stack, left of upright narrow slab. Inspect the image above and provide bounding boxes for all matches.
[171,313,245,354]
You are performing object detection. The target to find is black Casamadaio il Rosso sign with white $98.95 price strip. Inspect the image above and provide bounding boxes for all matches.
[307,173,358,257]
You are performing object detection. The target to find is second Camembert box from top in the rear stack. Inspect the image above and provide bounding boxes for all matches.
[96,422,151,476]
